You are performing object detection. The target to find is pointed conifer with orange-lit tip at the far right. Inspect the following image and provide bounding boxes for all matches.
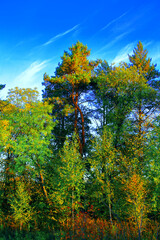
[129,41,160,136]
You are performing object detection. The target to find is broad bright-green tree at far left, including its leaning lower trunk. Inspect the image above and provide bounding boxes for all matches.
[0,88,55,225]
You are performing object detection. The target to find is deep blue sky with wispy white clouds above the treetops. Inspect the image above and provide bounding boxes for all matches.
[0,0,160,98]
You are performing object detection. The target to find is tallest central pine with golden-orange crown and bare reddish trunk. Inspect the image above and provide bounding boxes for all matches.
[44,41,99,155]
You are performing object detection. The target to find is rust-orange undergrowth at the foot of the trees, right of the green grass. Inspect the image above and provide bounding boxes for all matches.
[61,213,158,240]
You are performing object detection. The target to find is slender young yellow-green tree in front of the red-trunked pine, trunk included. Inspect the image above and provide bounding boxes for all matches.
[53,134,85,227]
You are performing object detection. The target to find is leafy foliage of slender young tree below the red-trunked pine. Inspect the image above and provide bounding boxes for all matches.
[59,134,84,208]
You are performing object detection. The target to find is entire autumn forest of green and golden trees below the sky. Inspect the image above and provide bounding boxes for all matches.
[0,41,160,240]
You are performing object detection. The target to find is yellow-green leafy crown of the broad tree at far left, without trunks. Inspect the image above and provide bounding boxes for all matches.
[1,88,55,174]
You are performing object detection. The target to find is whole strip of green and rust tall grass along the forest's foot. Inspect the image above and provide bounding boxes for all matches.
[0,213,160,240]
